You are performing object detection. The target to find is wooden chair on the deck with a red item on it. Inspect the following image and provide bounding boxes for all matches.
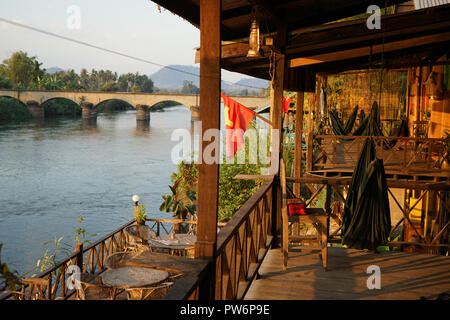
[280,159,329,270]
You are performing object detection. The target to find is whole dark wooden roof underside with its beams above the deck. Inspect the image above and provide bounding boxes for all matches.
[154,0,450,90]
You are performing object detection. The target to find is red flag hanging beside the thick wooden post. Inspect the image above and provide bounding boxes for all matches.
[221,93,255,158]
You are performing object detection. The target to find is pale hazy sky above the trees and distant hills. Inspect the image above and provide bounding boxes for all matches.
[0,0,245,82]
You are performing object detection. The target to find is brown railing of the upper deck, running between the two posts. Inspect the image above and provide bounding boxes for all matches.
[181,177,274,300]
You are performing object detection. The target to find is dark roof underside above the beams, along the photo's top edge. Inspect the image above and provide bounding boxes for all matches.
[152,0,407,41]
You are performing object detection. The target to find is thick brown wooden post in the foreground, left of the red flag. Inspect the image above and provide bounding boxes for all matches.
[195,0,221,262]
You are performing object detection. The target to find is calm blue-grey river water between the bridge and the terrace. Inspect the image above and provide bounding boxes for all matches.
[0,106,190,272]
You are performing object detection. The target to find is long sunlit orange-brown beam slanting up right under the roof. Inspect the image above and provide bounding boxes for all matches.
[289,32,450,68]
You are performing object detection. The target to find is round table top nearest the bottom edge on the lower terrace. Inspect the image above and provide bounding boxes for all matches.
[101,267,169,288]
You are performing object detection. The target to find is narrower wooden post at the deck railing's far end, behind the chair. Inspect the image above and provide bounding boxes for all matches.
[270,25,287,244]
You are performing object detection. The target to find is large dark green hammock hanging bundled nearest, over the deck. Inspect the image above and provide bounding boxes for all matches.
[342,138,391,250]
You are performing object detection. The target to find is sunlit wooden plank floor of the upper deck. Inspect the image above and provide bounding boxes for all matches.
[245,247,450,300]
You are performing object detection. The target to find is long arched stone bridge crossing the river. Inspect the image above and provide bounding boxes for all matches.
[0,90,269,121]
